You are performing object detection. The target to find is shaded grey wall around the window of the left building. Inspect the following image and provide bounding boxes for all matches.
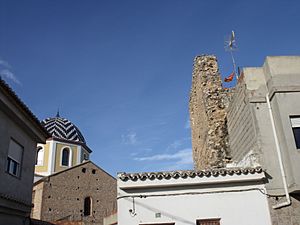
[0,110,36,225]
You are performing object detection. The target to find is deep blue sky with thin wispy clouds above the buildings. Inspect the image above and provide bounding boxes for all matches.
[0,0,300,175]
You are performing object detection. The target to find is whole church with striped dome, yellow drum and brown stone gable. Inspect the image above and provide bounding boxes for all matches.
[31,113,117,225]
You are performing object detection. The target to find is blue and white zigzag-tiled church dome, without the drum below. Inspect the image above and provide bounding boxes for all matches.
[42,114,86,144]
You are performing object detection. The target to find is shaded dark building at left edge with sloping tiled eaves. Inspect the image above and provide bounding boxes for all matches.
[0,78,49,225]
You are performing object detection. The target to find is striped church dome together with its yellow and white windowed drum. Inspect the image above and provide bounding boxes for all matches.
[35,113,92,176]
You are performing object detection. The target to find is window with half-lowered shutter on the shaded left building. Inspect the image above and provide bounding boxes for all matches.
[6,139,23,177]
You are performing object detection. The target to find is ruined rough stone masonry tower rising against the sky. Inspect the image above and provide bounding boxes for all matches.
[189,55,230,169]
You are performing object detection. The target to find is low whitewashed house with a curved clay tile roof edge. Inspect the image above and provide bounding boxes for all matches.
[118,167,271,225]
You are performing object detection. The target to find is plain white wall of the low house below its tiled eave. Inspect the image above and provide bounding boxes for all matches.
[118,174,271,225]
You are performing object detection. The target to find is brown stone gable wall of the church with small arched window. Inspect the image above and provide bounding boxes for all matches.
[34,162,117,225]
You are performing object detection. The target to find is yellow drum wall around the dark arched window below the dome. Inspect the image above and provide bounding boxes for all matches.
[54,143,77,172]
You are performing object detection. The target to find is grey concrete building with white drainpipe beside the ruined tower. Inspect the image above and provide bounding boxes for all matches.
[227,56,300,224]
